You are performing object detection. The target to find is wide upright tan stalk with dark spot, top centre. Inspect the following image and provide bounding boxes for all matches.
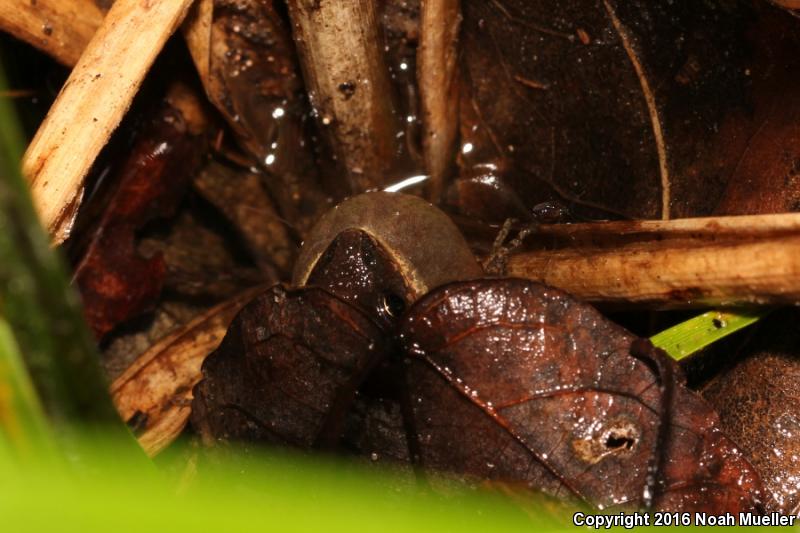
[288,0,401,193]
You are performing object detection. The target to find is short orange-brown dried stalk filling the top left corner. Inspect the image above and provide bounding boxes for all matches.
[0,0,103,67]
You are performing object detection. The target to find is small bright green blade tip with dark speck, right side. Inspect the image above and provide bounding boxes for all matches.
[650,307,771,361]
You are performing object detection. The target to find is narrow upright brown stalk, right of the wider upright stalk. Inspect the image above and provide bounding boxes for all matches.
[417,0,461,202]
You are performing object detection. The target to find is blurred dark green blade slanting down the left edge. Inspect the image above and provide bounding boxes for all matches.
[0,56,141,456]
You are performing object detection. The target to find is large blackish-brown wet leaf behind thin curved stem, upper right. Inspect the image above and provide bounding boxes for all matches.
[449,0,800,219]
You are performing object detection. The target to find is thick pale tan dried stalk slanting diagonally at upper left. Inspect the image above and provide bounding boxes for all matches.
[23,0,197,244]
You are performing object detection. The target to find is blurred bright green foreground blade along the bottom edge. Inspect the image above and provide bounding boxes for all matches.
[0,444,571,533]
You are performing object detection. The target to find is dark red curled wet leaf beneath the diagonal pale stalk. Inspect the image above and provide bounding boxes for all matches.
[74,98,203,339]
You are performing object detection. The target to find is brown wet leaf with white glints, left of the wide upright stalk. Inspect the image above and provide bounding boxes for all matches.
[200,0,325,230]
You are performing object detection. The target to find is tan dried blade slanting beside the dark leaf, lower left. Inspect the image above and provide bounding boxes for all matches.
[111,287,264,457]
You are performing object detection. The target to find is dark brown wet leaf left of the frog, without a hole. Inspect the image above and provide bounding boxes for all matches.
[192,286,386,449]
